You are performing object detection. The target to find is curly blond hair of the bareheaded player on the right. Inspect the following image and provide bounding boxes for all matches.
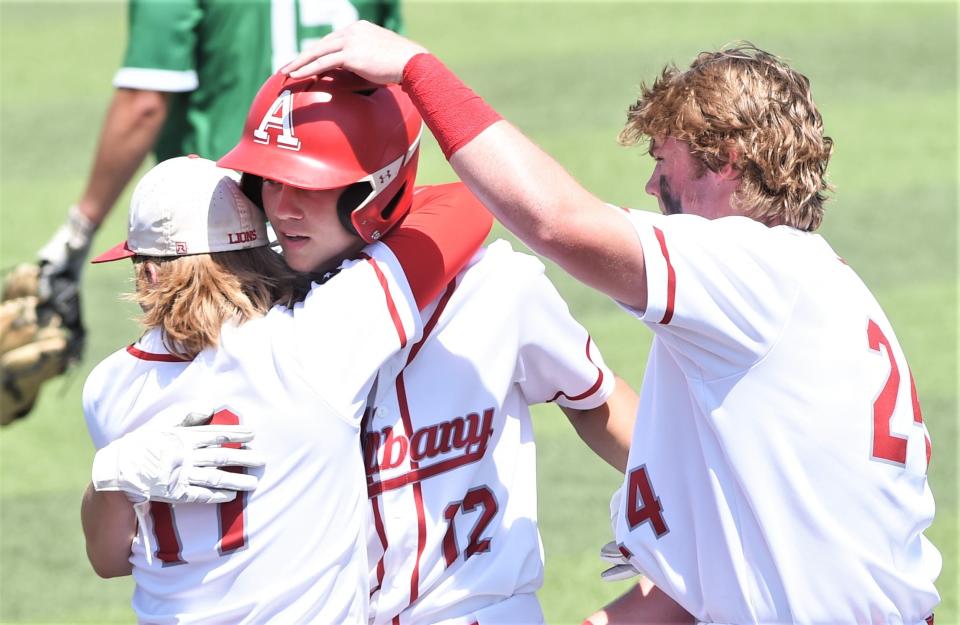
[620,42,833,231]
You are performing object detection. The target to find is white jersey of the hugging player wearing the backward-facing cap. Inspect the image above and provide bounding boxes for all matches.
[84,243,421,625]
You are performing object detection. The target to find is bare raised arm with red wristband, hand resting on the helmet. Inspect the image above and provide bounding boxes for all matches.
[283,22,646,310]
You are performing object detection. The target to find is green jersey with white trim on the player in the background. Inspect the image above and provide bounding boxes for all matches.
[113,0,401,161]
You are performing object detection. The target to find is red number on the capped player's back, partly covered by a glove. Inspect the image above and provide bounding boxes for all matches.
[150,409,247,566]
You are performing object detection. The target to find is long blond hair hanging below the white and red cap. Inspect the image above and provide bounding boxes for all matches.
[129,247,309,360]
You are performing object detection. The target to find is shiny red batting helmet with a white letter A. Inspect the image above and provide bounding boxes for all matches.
[223,70,422,242]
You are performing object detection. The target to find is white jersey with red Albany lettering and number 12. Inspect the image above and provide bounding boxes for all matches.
[364,241,614,625]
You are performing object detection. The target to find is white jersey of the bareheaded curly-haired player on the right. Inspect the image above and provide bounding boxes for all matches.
[613,212,941,625]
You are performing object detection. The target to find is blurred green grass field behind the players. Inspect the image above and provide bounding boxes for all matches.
[0,0,960,625]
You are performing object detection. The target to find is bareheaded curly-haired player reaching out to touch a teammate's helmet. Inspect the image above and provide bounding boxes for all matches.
[283,23,941,625]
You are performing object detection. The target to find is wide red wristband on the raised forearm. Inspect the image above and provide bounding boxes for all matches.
[402,52,503,159]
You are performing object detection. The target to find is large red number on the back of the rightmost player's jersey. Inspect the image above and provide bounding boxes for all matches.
[867,319,930,466]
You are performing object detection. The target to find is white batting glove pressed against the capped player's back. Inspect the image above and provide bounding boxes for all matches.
[93,414,264,503]
